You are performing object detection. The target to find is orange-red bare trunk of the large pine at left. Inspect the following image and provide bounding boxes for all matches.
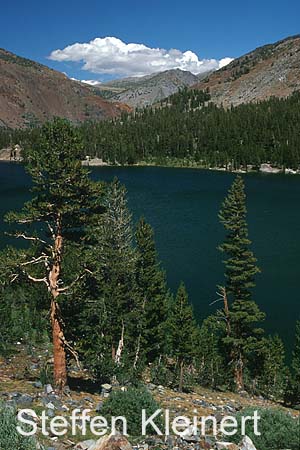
[49,217,67,391]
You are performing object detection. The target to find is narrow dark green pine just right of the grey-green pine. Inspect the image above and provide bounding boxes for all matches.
[136,218,169,362]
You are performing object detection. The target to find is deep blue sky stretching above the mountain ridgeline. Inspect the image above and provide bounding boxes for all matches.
[0,0,300,80]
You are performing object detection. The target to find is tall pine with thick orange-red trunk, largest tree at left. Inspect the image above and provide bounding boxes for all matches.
[7,119,101,389]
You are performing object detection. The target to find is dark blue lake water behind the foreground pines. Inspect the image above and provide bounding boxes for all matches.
[0,163,300,347]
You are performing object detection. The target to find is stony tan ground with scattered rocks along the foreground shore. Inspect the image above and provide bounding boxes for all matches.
[0,343,297,450]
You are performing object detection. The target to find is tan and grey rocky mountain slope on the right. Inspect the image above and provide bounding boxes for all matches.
[194,35,300,106]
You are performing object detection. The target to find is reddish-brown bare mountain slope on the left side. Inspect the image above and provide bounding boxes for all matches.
[0,49,129,128]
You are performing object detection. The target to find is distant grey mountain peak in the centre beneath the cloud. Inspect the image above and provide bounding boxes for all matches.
[95,69,199,108]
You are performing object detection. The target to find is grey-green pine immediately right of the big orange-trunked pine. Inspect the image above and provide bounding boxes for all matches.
[85,179,143,374]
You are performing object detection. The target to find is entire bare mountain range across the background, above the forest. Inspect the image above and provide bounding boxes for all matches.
[0,34,300,128]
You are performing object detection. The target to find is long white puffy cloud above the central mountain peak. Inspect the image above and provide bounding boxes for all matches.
[49,37,232,76]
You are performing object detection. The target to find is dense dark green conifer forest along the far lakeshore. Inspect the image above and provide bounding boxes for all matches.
[0,89,300,170]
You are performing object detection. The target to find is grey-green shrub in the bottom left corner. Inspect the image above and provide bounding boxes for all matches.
[0,404,37,450]
